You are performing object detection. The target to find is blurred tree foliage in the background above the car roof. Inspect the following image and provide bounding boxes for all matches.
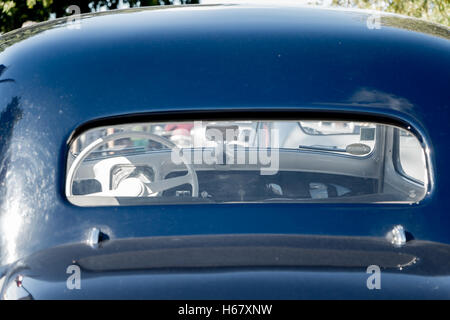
[0,0,450,33]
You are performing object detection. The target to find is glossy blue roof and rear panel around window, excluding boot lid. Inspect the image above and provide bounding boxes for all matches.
[0,6,450,296]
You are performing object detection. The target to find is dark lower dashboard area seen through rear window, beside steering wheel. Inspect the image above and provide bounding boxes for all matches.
[162,170,377,202]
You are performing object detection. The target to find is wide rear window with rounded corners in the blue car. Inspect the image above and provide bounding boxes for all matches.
[65,120,428,206]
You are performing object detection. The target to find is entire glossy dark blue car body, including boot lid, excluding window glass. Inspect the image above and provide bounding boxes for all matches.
[0,5,450,299]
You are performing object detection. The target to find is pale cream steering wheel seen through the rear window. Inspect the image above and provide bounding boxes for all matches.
[66,131,198,197]
